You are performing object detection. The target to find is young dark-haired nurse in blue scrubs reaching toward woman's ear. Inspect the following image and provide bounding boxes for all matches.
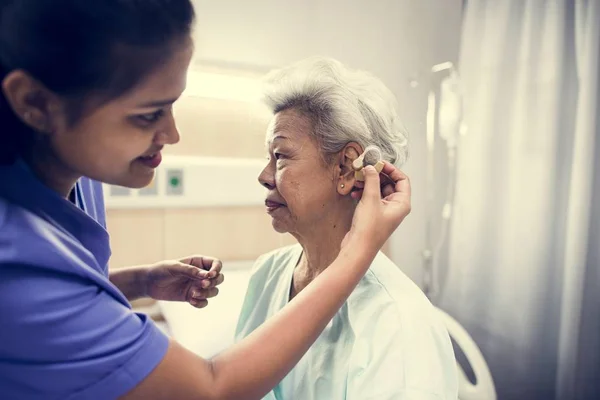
[0,0,410,400]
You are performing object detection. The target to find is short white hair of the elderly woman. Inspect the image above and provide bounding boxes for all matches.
[264,57,408,166]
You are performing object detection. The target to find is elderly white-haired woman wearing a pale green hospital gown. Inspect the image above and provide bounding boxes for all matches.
[236,58,457,400]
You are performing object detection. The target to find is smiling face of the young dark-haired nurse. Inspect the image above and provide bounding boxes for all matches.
[49,39,192,187]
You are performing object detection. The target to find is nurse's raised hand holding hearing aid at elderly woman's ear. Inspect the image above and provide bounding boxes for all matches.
[342,148,411,250]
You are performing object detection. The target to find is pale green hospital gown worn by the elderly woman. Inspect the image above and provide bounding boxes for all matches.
[236,245,458,400]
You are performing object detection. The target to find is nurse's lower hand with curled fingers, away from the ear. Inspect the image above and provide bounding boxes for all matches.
[144,256,224,308]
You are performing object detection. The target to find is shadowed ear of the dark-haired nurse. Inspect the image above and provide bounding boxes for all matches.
[2,70,63,134]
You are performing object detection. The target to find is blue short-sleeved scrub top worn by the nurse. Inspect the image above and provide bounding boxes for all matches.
[0,161,168,400]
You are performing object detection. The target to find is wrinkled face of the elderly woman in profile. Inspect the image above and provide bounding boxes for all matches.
[258,109,338,234]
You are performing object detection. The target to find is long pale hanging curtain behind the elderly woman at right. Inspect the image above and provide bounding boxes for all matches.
[439,0,600,400]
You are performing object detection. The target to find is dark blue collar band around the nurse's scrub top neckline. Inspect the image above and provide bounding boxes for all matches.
[0,159,111,274]
